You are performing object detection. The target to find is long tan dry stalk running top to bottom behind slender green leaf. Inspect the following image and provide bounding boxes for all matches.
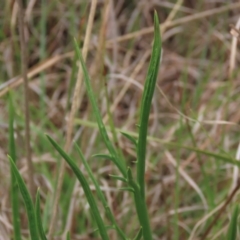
[48,0,97,240]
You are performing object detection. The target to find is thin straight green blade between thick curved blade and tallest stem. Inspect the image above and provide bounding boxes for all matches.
[75,144,127,240]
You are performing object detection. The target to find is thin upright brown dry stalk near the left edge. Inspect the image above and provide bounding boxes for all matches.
[18,0,35,198]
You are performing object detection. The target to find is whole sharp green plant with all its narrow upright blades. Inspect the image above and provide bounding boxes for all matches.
[9,12,171,240]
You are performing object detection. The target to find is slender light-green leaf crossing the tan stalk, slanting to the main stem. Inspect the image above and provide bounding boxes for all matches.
[74,40,127,177]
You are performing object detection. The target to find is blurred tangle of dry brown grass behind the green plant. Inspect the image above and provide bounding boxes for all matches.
[0,0,240,240]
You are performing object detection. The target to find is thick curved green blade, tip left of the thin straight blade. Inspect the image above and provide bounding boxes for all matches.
[47,135,109,240]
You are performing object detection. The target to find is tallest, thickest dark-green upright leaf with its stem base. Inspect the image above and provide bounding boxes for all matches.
[134,11,162,240]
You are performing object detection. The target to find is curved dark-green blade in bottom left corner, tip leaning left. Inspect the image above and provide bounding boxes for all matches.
[9,156,39,240]
